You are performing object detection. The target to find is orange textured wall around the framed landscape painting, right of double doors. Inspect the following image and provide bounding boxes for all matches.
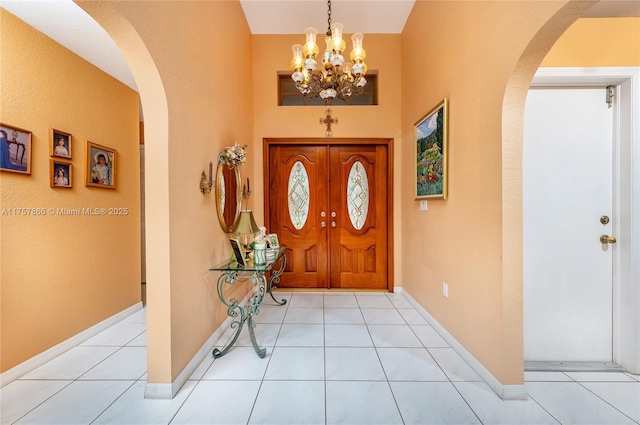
[400,1,578,385]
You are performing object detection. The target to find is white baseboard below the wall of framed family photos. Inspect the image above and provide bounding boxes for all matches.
[0,302,142,387]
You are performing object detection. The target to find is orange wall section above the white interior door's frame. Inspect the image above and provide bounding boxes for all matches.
[540,18,640,67]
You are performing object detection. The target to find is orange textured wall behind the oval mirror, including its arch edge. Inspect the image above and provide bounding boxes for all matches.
[78,1,259,384]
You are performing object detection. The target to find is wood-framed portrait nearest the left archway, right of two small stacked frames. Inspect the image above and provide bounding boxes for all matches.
[84,140,117,189]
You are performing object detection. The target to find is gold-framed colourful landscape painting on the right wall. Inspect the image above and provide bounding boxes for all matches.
[414,98,449,199]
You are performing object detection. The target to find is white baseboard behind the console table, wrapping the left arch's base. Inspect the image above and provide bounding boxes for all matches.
[144,291,253,399]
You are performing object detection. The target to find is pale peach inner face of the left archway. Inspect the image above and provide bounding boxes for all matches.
[76,1,172,383]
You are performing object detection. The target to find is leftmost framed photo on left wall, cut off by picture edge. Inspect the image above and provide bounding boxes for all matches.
[0,123,31,175]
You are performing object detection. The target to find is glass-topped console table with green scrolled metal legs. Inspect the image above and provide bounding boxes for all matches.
[209,246,289,358]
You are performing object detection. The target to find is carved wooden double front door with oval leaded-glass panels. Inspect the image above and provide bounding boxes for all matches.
[265,139,393,291]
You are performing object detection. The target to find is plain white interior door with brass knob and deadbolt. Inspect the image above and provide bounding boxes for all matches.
[523,87,614,362]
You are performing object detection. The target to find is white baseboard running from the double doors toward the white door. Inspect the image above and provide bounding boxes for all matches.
[395,286,528,400]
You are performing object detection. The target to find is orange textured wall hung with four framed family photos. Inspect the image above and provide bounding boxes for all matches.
[0,9,140,372]
